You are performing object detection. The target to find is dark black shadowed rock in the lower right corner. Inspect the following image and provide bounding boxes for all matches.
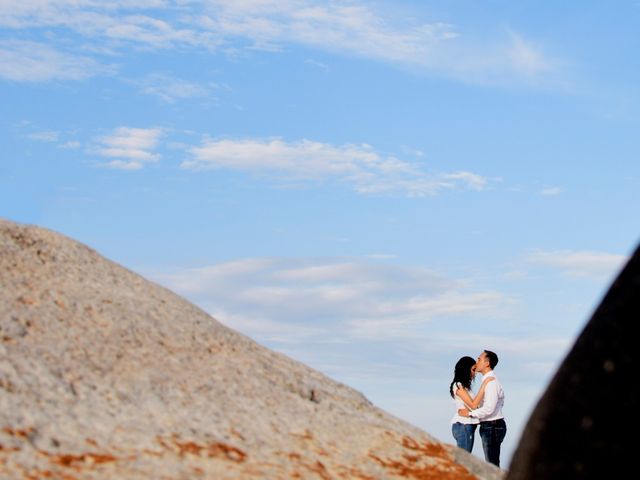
[507,249,640,480]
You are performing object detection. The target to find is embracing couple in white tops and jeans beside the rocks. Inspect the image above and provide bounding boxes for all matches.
[449,350,507,467]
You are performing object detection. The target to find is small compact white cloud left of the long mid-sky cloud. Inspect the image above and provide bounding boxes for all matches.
[92,127,163,170]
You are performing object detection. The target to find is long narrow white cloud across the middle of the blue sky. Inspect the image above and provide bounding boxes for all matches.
[182,138,489,196]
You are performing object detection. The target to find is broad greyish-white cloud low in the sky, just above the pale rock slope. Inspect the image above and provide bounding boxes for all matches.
[154,258,508,341]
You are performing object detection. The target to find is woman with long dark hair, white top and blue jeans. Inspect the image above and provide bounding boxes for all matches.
[449,357,494,452]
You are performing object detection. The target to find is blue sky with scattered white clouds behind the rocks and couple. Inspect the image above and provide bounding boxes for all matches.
[0,0,640,466]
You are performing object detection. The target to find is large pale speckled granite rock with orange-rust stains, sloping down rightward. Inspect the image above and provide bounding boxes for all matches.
[0,220,501,479]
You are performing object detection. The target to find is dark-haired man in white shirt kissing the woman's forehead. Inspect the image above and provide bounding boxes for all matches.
[458,350,507,467]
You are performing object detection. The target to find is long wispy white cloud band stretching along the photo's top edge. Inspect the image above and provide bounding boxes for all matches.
[0,0,558,83]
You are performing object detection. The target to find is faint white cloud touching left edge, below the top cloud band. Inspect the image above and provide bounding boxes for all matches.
[0,40,113,82]
